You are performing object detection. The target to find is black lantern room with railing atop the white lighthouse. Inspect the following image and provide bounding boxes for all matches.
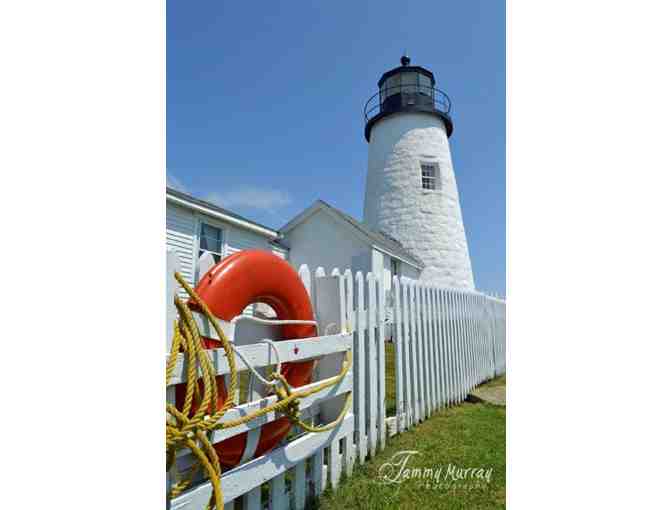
[364,55,453,142]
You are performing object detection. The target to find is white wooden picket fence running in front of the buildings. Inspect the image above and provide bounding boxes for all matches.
[166,252,505,510]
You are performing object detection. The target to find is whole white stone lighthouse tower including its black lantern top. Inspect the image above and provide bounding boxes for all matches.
[364,56,474,289]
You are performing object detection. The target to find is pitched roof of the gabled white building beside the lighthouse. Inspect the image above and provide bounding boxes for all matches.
[280,200,425,269]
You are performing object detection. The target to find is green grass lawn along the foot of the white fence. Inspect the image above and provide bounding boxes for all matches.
[313,344,506,510]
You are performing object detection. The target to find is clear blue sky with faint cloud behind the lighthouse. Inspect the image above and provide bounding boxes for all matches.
[166,0,506,294]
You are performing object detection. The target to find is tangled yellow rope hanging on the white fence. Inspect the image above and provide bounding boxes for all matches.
[166,272,352,510]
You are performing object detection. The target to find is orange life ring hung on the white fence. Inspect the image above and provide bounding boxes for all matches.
[175,250,317,469]
